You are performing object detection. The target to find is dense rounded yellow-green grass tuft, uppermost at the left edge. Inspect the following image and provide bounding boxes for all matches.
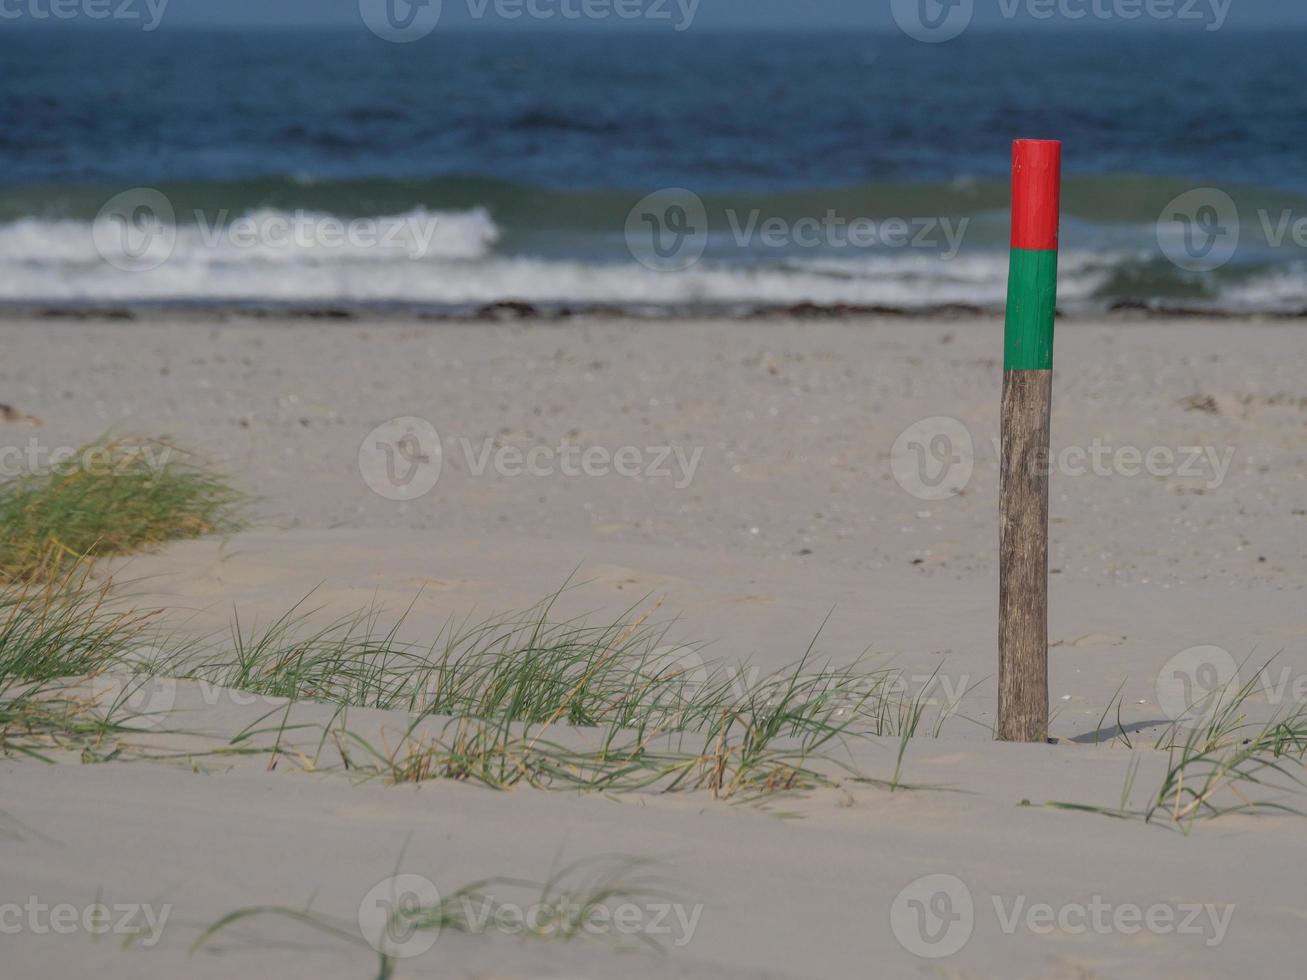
[0,438,244,581]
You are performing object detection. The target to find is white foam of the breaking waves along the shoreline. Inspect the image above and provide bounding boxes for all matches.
[0,209,1286,310]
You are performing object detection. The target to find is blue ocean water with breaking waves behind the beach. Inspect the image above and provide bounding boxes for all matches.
[0,26,1307,312]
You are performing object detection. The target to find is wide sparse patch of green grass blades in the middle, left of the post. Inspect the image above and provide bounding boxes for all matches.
[154,593,951,798]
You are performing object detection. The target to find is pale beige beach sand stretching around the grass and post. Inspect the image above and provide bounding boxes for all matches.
[0,314,1307,980]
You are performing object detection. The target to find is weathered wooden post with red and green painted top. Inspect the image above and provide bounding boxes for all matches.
[999,140,1061,742]
